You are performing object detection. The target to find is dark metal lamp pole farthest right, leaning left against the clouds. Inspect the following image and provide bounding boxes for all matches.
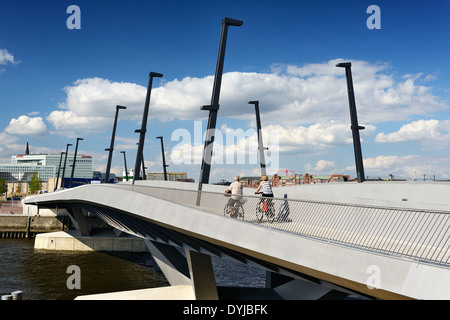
[336,62,365,183]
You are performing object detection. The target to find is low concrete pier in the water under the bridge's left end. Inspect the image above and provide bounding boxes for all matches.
[34,230,148,252]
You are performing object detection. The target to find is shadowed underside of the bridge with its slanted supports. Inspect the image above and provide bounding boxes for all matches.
[48,203,372,300]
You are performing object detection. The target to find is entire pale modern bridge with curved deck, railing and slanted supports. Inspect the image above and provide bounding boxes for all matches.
[25,181,450,299]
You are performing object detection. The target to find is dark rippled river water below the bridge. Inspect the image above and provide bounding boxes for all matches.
[0,238,265,300]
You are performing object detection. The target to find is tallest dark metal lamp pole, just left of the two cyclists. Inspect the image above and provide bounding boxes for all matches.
[197,18,243,195]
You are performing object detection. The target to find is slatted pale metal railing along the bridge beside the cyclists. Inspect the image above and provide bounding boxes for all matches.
[114,185,450,266]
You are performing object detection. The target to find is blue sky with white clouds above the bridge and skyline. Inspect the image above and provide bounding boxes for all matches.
[0,0,450,182]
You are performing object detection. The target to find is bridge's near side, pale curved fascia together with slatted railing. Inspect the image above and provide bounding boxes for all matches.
[26,180,450,299]
